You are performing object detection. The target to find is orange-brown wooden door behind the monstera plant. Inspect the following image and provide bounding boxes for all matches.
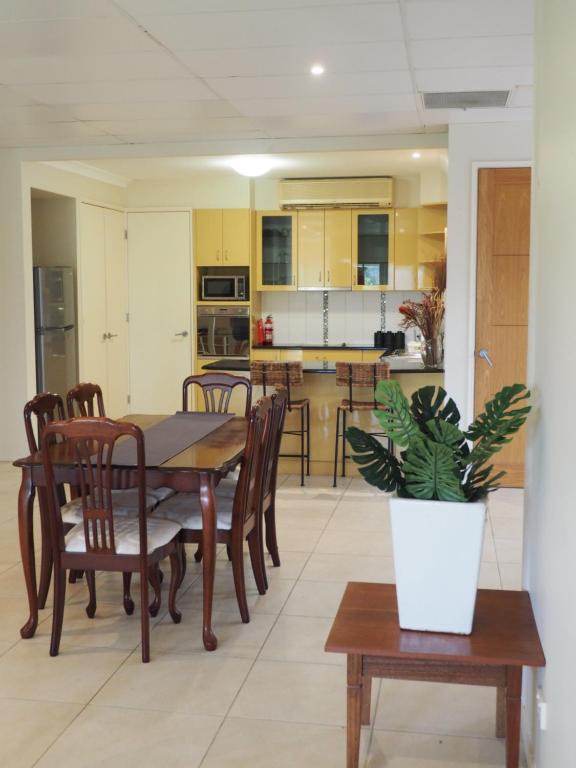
[475,168,530,487]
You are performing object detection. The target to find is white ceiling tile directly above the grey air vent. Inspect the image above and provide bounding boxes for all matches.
[415,67,533,91]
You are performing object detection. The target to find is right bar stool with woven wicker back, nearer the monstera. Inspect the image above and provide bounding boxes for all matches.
[334,363,392,488]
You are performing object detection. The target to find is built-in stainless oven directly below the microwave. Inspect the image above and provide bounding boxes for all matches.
[196,307,250,360]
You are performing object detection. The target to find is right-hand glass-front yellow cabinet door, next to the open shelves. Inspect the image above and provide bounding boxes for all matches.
[352,209,394,291]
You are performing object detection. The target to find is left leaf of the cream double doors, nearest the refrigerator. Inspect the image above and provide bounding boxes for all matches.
[77,203,108,390]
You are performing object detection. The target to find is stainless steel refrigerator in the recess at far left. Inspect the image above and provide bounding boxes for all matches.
[34,267,78,397]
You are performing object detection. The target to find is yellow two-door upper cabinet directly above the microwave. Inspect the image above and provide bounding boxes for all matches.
[194,208,250,267]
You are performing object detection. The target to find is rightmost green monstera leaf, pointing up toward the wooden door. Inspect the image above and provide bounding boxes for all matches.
[466,384,530,464]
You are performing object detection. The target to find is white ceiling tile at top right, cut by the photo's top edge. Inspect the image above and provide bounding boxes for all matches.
[405,0,533,39]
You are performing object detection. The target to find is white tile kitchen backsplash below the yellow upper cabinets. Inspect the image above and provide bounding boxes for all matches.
[262,291,420,345]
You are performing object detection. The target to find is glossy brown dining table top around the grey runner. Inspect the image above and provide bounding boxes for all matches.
[14,414,248,472]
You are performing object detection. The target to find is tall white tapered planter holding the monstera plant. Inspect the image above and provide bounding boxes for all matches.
[390,497,486,635]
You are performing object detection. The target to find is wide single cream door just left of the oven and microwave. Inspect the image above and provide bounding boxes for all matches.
[128,211,192,413]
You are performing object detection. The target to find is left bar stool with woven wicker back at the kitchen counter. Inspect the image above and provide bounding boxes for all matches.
[250,360,310,485]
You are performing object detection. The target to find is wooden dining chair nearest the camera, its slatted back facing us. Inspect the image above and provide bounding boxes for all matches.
[41,417,181,662]
